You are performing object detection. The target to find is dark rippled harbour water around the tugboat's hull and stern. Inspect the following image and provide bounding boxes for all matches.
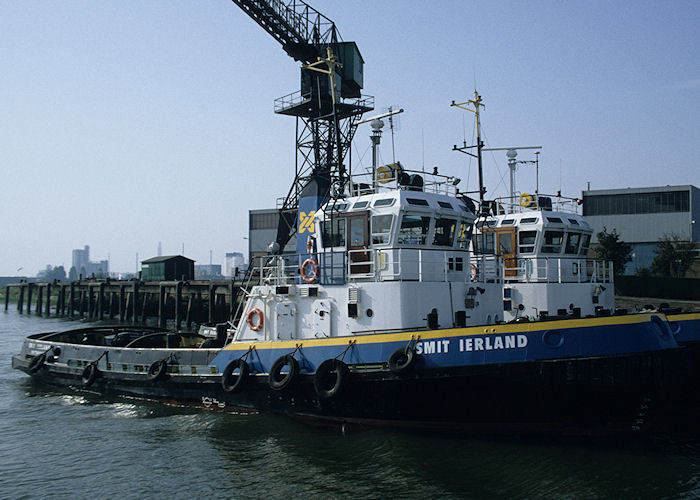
[0,310,700,499]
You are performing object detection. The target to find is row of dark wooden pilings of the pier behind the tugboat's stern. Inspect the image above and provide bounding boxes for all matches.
[5,280,241,330]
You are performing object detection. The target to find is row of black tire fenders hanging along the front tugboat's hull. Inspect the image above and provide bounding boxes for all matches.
[27,339,418,399]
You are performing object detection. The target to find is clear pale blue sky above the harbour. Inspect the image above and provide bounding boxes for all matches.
[0,0,700,276]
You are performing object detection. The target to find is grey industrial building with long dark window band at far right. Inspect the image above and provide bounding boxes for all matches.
[583,185,700,274]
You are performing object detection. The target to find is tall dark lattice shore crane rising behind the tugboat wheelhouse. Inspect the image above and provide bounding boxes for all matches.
[233,0,374,253]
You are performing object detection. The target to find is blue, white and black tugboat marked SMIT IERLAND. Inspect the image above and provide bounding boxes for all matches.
[12,93,678,434]
